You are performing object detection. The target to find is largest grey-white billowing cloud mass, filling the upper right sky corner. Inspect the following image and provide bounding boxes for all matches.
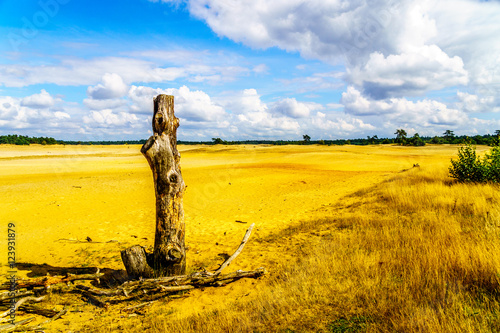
[162,0,500,105]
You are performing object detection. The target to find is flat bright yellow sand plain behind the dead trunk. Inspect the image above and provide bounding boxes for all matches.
[0,145,487,330]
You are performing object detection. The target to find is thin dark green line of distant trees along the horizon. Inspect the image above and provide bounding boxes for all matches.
[0,129,500,146]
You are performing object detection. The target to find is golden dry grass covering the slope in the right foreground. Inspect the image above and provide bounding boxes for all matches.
[89,165,500,332]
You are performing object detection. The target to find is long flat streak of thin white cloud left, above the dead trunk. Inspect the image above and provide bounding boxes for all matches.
[0,52,250,87]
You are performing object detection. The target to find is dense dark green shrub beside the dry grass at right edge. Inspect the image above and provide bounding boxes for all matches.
[449,143,500,183]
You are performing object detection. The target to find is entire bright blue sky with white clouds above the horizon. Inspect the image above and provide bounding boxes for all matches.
[0,0,500,140]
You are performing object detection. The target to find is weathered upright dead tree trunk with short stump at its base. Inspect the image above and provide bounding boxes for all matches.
[122,95,186,277]
